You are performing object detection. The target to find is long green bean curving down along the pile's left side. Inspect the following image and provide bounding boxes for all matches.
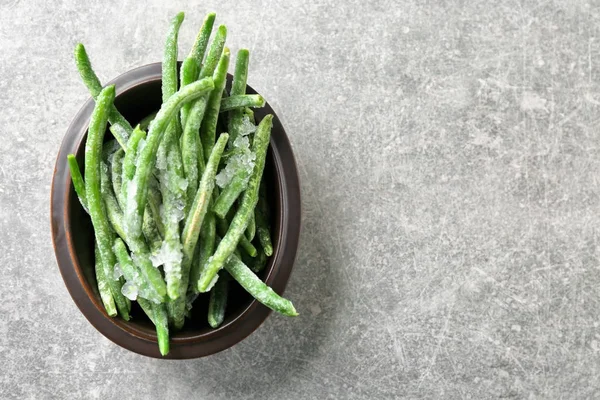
[85,85,129,320]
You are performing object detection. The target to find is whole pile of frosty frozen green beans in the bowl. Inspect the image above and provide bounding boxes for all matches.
[67,13,298,355]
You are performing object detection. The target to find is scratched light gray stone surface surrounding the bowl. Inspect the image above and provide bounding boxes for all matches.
[0,0,600,399]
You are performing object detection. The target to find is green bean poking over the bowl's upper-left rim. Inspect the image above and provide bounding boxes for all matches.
[75,43,132,150]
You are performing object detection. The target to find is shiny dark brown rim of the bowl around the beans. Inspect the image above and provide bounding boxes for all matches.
[50,63,301,359]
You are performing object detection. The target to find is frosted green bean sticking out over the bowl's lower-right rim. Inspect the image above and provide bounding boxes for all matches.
[225,250,298,317]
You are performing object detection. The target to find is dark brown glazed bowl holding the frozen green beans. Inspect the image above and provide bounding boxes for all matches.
[50,63,301,359]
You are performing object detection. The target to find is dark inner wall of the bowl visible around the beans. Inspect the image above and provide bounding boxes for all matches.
[66,76,282,341]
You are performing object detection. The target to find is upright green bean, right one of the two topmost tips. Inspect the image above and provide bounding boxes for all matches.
[180,13,216,128]
